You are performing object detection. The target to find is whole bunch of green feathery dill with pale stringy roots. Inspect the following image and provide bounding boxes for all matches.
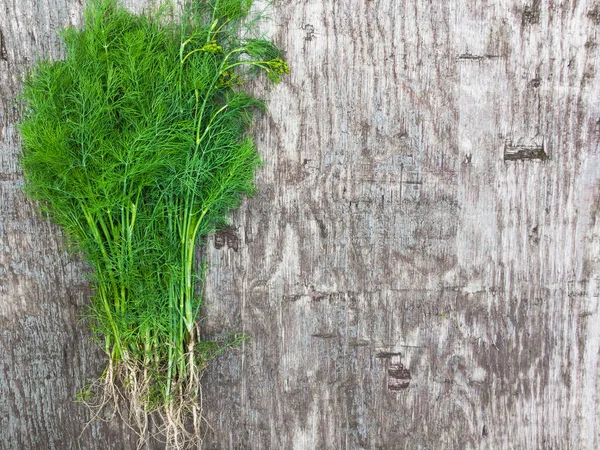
[20,0,289,448]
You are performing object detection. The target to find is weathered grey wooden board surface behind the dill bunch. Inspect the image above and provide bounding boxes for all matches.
[0,0,600,450]
